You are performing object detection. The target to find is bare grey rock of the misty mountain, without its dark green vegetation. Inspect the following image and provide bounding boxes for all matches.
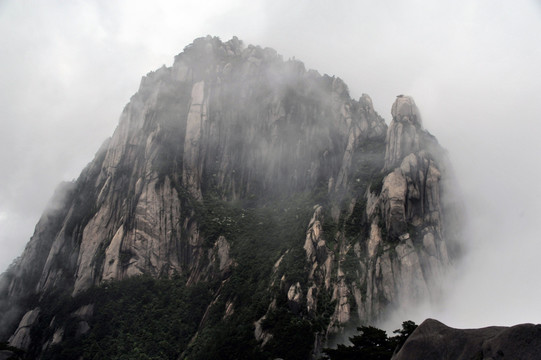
[0,37,456,358]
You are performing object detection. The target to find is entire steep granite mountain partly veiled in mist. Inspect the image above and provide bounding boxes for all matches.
[0,37,459,359]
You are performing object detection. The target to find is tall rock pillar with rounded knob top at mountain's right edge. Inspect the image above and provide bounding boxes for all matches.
[362,96,456,316]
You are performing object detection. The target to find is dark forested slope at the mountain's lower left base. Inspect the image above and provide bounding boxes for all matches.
[35,276,212,360]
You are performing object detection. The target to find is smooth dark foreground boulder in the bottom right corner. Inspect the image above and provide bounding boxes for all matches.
[392,319,541,360]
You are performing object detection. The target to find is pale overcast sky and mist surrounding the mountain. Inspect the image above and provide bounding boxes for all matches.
[0,0,541,327]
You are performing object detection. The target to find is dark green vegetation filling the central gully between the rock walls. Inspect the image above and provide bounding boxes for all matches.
[184,193,320,359]
